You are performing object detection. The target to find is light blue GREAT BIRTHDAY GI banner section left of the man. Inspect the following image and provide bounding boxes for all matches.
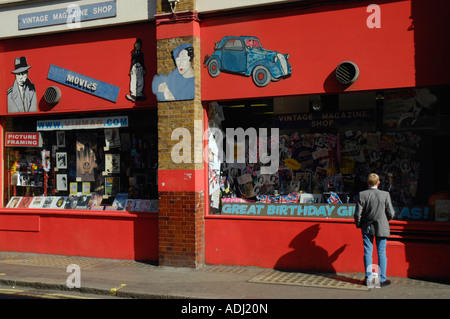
[222,203,355,218]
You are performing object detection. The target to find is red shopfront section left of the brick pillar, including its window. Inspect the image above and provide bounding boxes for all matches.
[0,22,158,260]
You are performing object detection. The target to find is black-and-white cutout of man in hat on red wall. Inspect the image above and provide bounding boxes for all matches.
[8,56,37,113]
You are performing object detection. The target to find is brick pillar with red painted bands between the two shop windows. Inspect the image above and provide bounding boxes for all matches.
[156,0,206,268]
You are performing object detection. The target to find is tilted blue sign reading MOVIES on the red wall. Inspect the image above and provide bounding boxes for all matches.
[47,64,120,102]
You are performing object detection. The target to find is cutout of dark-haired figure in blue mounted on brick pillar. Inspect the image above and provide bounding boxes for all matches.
[152,43,195,101]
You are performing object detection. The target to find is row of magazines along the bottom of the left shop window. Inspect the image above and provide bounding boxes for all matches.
[6,193,159,213]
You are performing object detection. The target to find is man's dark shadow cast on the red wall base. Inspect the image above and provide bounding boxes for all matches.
[274,224,347,273]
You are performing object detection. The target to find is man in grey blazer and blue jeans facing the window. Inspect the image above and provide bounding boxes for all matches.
[354,173,395,287]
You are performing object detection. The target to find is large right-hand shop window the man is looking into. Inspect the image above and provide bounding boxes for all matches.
[208,88,450,221]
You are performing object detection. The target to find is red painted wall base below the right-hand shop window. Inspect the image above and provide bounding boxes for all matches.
[205,216,450,279]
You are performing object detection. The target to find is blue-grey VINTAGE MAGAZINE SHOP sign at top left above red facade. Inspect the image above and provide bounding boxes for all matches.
[19,1,117,30]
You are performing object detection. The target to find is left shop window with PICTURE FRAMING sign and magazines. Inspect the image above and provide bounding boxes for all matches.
[4,110,158,212]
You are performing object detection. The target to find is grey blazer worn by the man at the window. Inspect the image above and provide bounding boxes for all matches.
[354,188,395,237]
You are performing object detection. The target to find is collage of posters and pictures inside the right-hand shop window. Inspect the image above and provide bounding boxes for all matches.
[209,100,421,213]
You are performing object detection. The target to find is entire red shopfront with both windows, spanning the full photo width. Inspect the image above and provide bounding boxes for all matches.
[0,0,450,278]
